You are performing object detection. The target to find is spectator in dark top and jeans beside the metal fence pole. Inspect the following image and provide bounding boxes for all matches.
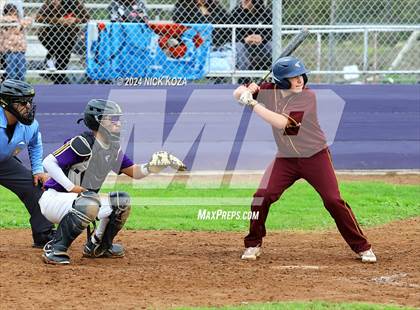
[230,0,272,70]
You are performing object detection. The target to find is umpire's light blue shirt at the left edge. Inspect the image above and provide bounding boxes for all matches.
[0,108,44,174]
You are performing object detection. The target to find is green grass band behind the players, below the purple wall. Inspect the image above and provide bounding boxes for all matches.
[0,182,420,231]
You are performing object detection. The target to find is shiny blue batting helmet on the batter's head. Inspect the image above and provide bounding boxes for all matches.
[272,56,308,89]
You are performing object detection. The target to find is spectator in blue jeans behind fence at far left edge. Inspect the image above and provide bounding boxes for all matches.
[0,3,32,81]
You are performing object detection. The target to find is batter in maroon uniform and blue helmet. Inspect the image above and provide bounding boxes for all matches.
[234,57,376,263]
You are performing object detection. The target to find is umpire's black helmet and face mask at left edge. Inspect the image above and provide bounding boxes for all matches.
[0,80,36,125]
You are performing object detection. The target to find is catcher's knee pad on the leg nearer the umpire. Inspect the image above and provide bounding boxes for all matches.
[70,191,101,227]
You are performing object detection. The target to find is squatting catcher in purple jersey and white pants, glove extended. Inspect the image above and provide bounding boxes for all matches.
[39,99,186,264]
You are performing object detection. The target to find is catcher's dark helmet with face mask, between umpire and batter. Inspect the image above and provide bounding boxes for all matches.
[83,99,122,142]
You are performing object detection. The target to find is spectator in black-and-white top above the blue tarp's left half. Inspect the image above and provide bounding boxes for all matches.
[108,0,149,23]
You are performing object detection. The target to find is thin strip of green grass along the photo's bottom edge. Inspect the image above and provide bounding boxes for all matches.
[176,301,414,310]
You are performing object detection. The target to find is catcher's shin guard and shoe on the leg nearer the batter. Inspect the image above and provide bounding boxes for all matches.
[83,192,131,258]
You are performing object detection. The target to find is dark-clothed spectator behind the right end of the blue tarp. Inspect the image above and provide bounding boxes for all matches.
[172,0,229,47]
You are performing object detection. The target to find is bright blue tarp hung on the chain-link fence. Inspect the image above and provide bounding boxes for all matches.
[86,22,213,80]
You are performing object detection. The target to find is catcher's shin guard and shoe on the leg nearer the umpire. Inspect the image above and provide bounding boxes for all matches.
[43,192,100,264]
